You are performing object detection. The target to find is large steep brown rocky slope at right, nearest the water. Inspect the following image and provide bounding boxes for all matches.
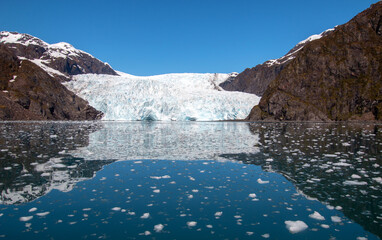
[247,2,382,121]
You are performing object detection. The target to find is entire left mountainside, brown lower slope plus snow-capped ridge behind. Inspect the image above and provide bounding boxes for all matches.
[0,32,117,120]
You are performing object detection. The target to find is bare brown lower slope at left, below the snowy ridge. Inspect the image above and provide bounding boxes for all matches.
[0,44,102,120]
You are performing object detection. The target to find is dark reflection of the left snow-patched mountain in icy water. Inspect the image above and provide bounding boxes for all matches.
[0,122,112,204]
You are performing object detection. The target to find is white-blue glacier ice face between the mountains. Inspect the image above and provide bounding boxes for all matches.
[65,73,260,121]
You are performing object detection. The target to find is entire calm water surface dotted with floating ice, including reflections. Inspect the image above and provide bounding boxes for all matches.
[0,122,382,240]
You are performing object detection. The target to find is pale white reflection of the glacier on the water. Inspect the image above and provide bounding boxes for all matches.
[69,122,258,161]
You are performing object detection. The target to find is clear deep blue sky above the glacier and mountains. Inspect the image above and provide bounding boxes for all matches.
[0,0,378,75]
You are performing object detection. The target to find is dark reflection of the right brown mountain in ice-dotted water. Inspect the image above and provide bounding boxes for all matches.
[222,123,382,237]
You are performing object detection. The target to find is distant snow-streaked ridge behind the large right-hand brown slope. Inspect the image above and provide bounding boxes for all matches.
[220,29,333,96]
